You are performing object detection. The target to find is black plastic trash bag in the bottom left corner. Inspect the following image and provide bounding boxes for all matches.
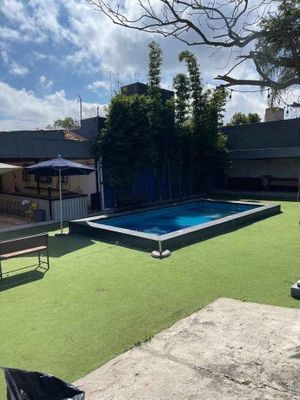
[2,368,85,400]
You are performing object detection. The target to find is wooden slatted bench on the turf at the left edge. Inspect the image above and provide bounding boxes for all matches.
[0,233,50,280]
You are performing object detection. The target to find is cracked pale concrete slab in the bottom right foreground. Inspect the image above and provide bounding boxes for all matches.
[75,299,300,400]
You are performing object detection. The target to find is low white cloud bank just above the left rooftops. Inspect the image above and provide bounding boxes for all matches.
[0,81,104,130]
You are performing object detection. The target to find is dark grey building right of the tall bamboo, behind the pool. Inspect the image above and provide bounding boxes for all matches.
[224,118,300,190]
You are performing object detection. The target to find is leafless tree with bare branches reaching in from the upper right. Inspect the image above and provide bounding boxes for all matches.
[87,0,300,104]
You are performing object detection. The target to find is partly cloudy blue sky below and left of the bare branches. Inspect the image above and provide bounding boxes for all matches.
[0,0,298,131]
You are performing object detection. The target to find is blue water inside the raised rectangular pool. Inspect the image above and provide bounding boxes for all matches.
[93,201,259,236]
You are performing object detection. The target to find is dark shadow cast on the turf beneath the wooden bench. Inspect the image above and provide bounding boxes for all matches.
[0,267,47,292]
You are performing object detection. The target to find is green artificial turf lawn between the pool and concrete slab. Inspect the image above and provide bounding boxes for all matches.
[0,198,300,399]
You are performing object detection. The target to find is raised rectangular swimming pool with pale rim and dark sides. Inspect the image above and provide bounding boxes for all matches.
[69,200,280,251]
